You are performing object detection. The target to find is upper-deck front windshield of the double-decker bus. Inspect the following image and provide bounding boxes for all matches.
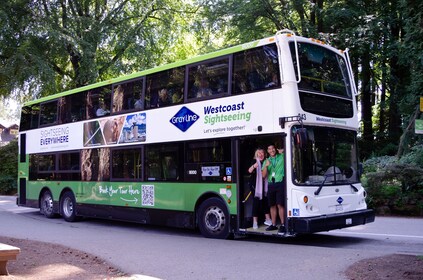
[289,42,352,99]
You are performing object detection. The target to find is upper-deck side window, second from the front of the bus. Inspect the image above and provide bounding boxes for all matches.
[188,57,229,99]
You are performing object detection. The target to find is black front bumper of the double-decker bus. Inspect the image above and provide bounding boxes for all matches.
[290,209,375,233]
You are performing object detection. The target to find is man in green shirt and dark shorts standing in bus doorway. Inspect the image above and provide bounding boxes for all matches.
[262,144,285,232]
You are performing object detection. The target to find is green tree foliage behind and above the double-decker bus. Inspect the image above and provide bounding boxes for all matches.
[0,0,423,162]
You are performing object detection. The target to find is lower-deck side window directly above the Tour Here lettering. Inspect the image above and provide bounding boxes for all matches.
[112,148,142,180]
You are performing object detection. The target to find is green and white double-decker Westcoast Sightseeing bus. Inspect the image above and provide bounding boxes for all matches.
[17,30,374,238]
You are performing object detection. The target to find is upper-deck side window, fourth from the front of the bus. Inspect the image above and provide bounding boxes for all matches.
[112,78,144,113]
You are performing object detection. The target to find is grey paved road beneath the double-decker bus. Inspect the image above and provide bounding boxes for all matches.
[0,196,423,280]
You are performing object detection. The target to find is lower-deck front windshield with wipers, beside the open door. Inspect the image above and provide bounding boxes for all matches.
[292,126,359,185]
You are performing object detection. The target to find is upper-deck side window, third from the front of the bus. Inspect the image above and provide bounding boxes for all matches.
[145,67,185,108]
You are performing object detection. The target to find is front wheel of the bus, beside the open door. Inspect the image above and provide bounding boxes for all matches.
[197,197,230,239]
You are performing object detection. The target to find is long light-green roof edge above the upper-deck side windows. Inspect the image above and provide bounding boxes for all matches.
[24,36,276,106]
